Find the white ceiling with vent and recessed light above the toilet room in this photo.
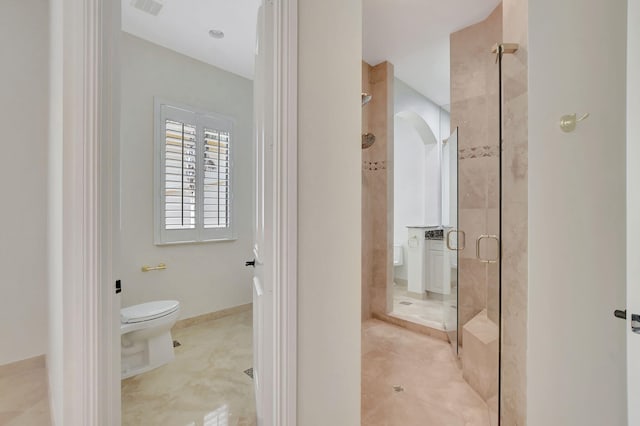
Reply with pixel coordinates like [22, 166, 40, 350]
[122, 0, 260, 79]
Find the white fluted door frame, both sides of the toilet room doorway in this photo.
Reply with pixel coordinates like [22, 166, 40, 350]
[58, 0, 298, 426]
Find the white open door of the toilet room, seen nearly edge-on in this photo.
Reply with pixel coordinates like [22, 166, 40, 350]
[253, 0, 274, 426]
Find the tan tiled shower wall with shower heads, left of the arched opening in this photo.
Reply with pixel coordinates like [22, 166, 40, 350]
[358, 62, 393, 320]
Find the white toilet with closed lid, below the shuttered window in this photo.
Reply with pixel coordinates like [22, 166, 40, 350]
[120, 300, 180, 379]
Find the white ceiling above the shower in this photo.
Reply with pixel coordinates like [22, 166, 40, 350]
[363, 0, 500, 107]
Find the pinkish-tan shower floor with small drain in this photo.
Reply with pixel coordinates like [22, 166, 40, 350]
[361, 320, 491, 426]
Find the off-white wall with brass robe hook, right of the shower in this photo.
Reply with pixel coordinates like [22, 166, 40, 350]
[527, 0, 637, 426]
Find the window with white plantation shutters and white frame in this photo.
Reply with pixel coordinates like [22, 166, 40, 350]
[155, 100, 233, 244]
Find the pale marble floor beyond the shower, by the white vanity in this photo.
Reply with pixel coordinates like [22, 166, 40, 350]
[391, 284, 457, 331]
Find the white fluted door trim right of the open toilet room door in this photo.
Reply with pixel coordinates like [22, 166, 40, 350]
[273, 0, 298, 426]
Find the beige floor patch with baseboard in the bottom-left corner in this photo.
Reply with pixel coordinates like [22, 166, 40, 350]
[0, 357, 51, 426]
